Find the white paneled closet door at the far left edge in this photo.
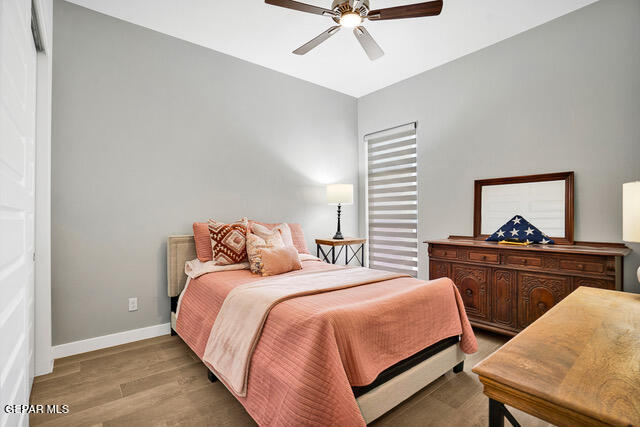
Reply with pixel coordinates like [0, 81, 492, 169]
[0, 0, 36, 426]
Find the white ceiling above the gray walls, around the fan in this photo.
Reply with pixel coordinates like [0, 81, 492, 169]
[63, 0, 596, 97]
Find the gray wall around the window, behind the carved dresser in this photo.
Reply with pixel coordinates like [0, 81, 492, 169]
[358, 0, 640, 292]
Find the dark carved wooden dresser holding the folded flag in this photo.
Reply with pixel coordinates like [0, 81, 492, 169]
[425, 238, 631, 335]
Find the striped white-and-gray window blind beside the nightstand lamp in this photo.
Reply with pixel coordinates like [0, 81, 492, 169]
[365, 123, 418, 277]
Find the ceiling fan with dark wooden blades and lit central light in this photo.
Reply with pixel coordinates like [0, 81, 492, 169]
[265, 0, 442, 61]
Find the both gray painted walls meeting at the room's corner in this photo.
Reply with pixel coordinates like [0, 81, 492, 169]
[52, 0, 640, 345]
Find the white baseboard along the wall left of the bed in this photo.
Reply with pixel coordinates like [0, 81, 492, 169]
[51, 323, 171, 359]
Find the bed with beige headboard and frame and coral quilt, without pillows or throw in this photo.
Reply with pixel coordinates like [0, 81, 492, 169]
[167, 235, 477, 425]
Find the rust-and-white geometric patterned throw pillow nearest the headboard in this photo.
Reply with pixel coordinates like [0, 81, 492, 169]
[208, 218, 248, 265]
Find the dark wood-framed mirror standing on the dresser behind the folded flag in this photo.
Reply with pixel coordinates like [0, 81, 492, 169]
[473, 172, 573, 245]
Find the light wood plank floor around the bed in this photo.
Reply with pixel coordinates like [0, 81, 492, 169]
[30, 331, 548, 427]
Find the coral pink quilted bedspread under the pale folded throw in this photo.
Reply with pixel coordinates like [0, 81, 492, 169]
[176, 261, 477, 426]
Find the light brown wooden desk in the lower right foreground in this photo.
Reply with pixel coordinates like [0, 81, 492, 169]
[473, 287, 640, 426]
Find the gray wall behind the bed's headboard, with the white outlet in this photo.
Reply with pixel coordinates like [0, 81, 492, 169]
[52, 0, 357, 345]
